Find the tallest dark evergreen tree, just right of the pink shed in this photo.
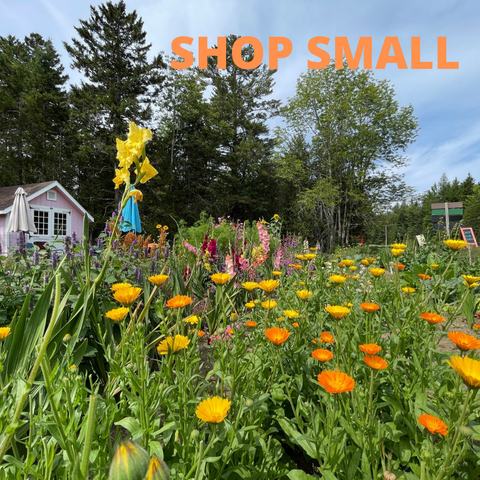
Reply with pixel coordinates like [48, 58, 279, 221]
[64, 0, 165, 229]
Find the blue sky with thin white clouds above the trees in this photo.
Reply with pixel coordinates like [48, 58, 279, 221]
[0, 0, 480, 192]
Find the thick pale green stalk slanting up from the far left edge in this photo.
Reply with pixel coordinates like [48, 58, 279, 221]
[0, 273, 60, 462]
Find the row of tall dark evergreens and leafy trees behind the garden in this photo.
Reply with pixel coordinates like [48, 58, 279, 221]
[0, 1, 476, 250]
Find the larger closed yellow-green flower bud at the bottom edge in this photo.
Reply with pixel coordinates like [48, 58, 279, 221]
[108, 440, 149, 480]
